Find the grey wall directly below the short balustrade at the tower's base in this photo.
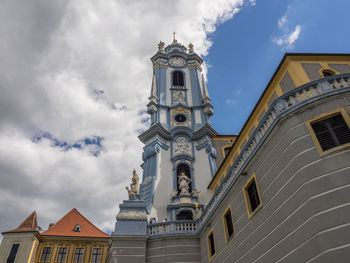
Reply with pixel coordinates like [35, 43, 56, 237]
[146, 235, 201, 263]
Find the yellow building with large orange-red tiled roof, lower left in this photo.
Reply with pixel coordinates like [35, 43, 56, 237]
[35, 208, 110, 263]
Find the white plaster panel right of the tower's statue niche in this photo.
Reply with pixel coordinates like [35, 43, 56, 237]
[193, 148, 212, 204]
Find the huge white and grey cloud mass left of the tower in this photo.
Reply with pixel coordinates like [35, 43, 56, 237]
[0, 0, 247, 235]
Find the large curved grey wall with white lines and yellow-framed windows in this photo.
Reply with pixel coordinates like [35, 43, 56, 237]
[200, 94, 350, 263]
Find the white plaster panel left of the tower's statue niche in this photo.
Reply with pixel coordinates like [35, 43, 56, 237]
[149, 148, 173, 222]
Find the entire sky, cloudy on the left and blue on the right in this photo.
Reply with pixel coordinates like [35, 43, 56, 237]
[0, 0, 350, 235]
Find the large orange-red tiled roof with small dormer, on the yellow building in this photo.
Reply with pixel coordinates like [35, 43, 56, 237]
[41, 208, 110, 237]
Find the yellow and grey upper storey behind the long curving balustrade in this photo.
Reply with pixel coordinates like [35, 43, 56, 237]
[208, 53, 350, 194]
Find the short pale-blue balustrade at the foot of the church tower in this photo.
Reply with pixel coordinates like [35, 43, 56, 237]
[148, 220, 197, 235]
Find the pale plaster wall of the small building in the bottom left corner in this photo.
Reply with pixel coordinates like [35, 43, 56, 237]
[0, 232, 39, 263]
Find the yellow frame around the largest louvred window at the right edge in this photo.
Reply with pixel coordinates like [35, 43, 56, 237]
[305, 108, 350, 156]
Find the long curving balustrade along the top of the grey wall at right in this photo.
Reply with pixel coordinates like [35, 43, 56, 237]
[198, 73, 350, 231]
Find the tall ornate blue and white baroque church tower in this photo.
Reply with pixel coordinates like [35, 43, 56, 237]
[139, 34, 217, 221]
